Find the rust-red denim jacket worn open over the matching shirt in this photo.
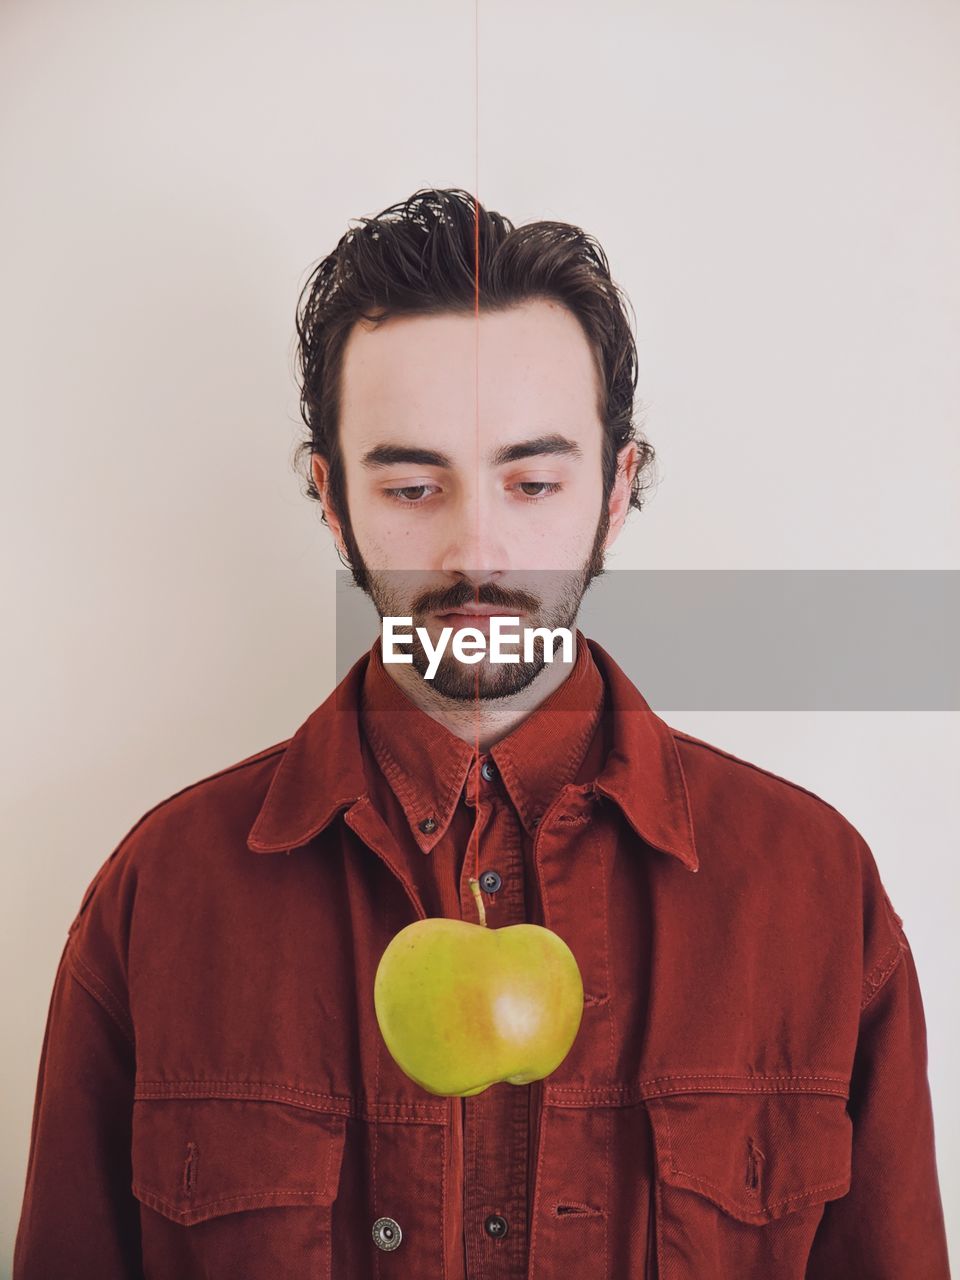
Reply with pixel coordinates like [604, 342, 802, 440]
[14, 634, 948, 1280]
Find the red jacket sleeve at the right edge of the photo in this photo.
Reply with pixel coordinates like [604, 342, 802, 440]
[806, 916, 950, 1280]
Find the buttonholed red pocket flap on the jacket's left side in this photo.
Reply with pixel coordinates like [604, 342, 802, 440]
[132, 1098, 347, 1226]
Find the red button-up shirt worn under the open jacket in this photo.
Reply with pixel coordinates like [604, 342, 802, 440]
[361, 627, 611, 1277]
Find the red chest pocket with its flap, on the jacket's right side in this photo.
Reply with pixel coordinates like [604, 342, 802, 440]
[646, 1093, 852, 1280]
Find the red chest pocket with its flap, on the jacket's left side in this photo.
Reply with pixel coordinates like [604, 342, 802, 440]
[132, 1098, 346, 1280]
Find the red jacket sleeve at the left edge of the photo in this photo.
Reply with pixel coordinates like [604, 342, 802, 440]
[13, 936, 143, 1280]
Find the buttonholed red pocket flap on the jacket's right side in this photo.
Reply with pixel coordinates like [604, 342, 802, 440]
[648, 1093, 852, 1224]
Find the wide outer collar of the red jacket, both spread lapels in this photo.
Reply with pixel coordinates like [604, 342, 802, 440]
[247, 635, 699, 872]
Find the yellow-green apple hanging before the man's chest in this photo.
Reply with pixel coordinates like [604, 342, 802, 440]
[374, 916, 584, 1098]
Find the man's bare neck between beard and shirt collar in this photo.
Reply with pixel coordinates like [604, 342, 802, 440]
[384, 628, 577, 753]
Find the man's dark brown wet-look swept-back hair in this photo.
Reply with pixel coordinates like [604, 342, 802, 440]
[296, 188, 654, 527]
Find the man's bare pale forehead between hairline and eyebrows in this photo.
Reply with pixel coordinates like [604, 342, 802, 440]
[340, 298, 600, 445]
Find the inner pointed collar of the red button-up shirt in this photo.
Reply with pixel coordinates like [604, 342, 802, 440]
[360, 632, 604, 854]
